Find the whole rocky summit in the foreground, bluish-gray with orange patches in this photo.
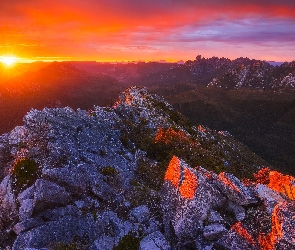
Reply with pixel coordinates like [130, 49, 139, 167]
[0, 87, 295, 250]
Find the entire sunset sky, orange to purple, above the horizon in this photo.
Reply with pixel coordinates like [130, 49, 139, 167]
[0, 0, 295, 61]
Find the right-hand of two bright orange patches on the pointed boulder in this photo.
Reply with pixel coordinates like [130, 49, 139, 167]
[179, 168, 198, 199]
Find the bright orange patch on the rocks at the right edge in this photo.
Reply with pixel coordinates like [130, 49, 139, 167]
[268, 171, 295, 200]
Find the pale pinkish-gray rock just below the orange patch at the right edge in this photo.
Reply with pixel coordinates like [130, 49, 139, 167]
[256, 184, 286, 214]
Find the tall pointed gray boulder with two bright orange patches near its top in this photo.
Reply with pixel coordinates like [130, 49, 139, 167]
[162, 156, 225, 239]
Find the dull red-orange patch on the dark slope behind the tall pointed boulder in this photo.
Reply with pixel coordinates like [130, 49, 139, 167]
[155, 127, 189, 144]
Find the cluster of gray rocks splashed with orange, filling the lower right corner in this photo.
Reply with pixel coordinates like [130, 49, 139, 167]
[162, 156, 295, 249]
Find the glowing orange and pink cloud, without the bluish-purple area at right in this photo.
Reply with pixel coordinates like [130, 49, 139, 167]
[0, 0, 295, 60]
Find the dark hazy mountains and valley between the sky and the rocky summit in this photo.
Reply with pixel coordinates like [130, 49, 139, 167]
[0, 56, 295, 174]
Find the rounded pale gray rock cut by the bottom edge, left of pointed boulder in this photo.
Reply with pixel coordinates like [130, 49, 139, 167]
[139, 231, 171, 250]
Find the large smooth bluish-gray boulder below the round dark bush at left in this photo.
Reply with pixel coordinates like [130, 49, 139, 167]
[34, 179, 70, 213]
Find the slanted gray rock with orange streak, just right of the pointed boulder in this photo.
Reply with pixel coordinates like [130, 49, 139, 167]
[215, 172, 257, 205]
